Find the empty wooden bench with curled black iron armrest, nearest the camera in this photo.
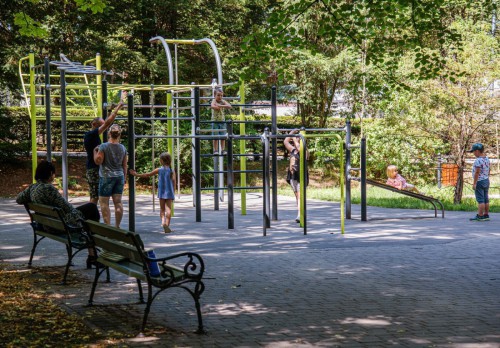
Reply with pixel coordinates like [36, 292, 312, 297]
[84, 220, 205, 335]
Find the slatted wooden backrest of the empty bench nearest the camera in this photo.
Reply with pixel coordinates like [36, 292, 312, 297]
[85, 220, 145, 264]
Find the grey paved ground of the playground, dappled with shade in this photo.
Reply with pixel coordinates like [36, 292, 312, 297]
[0, 194, 500, 348]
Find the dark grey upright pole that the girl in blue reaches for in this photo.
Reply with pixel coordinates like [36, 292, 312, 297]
[128, 94, 135, 232]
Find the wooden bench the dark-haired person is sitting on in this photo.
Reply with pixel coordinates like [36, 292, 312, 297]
[24, 203, 105, 284]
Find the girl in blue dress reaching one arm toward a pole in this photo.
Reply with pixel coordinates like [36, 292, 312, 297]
[129, 152, 176, 233]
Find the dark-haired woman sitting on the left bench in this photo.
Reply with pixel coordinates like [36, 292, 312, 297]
[16, 160, 101, 268]
